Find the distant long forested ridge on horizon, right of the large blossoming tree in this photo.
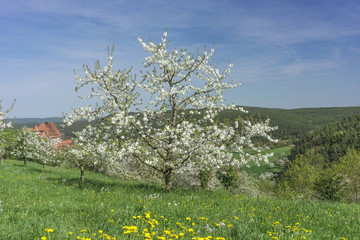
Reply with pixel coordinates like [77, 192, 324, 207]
[220, 106, 360, 139]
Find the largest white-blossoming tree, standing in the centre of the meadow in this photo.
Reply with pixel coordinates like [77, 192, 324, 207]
[64, 31, 274, 190]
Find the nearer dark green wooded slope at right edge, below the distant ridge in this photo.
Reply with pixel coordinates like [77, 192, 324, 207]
[291, 114, 360, 163]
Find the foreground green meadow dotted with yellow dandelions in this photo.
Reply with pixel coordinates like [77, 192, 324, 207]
[0, 160, 360, 240]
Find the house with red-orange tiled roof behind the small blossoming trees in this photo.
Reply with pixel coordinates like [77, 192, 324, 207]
[29, 122, 72, 149]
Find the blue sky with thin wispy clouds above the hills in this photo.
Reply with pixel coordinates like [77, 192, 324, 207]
[0, 0, 360, 118]
